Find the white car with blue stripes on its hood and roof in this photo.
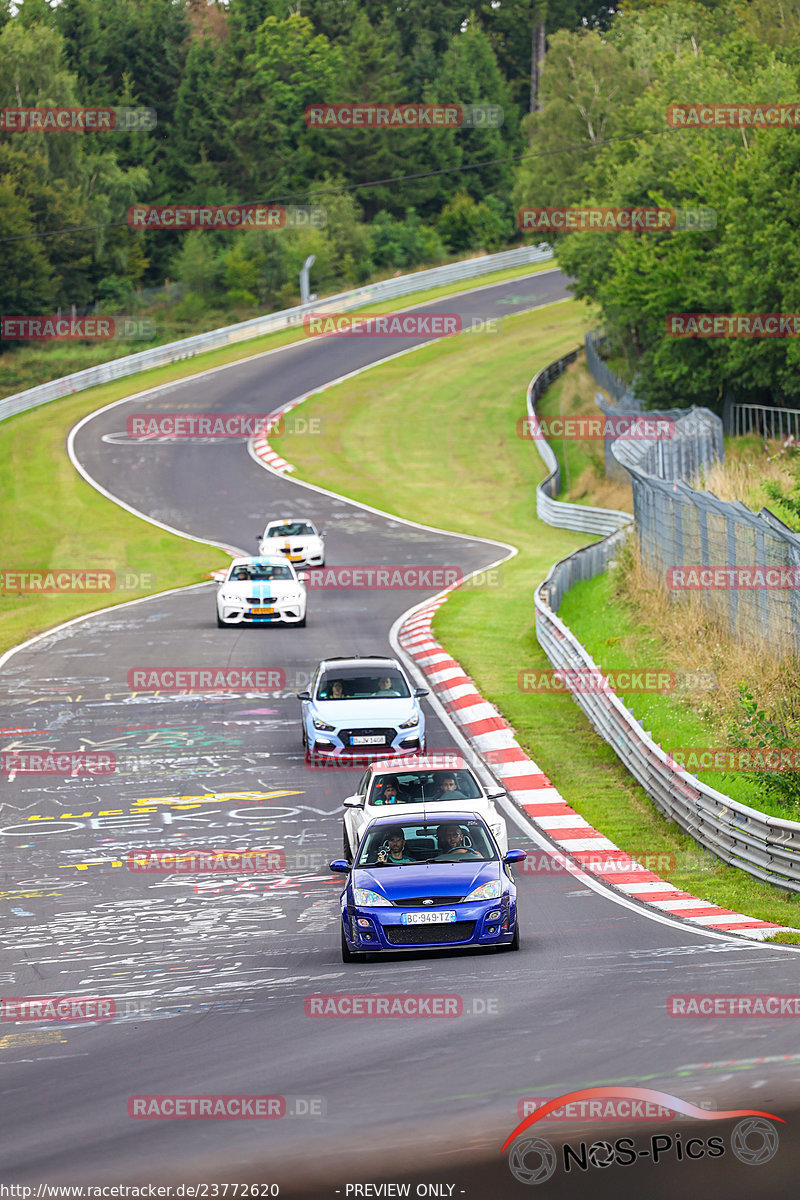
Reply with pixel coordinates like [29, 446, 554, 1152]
[217, 557, 306, 628]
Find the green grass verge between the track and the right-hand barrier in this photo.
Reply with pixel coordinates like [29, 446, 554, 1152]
[273, 301, 800, 925]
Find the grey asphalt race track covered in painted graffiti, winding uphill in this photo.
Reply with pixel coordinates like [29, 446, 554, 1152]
[0, 275, 796, 1196]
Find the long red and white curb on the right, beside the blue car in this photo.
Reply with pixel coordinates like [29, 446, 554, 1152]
[398, 595, 786, 940]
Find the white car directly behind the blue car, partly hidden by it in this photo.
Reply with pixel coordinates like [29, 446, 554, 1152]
[344, 751, 509, 862]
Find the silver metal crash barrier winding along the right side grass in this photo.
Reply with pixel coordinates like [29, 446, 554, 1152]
[528, 338, 800, 892]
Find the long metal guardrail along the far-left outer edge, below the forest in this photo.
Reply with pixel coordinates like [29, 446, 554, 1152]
[0, 245, 553, 420]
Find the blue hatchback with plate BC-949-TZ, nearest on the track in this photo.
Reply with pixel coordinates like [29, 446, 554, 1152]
[330, 811, 525, 962]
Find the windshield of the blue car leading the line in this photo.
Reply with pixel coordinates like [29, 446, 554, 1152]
[356, 821, 498, 866]
